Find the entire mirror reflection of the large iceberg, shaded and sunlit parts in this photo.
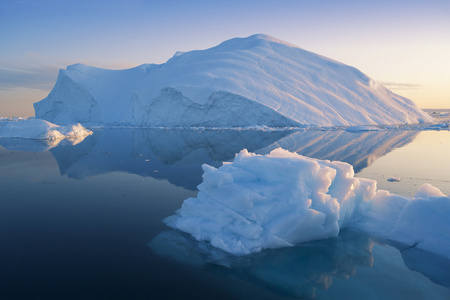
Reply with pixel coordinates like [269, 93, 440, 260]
[0, 128, 418, 190]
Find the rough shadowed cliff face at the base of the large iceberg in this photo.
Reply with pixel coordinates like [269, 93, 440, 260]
[134, 87, 300, 127]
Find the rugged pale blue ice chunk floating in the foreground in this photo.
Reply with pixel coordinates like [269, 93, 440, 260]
[165, 148, 450, 257]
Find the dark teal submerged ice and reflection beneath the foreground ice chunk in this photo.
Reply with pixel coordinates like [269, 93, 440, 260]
[149, 229, 450, 299]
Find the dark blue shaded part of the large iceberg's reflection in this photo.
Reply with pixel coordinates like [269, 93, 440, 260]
[51, 129, 289, 190]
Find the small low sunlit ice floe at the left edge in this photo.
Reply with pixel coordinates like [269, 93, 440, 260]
[0, 119, 92, 140]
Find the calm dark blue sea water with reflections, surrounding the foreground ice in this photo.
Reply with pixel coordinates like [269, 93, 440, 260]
[0, 129, 450, 299]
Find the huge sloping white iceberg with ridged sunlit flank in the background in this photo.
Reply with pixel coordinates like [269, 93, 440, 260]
[34, 34, 432, 127]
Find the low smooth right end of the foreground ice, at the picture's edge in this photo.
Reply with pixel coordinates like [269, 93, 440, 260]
[356, 183, 450, 258]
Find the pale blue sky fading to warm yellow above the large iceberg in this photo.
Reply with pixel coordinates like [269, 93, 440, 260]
[0, 0, 450, 116]
